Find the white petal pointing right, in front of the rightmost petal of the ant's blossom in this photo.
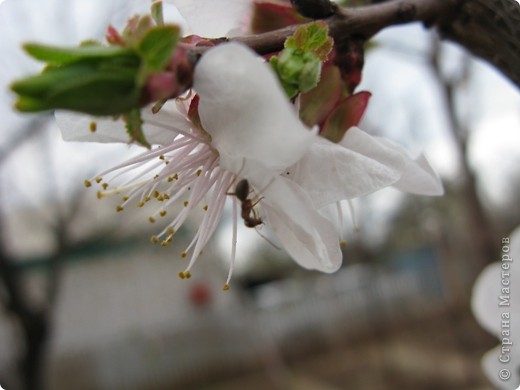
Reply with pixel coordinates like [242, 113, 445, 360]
[289, 134, 406, 208]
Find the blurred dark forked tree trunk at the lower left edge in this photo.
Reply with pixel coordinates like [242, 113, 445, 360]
[0, 116, 86, 390]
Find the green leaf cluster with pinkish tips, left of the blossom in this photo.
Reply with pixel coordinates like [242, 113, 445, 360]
[11, 7, 180, 119]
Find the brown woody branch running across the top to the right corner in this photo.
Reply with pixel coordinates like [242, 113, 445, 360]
[223, 0, 520, 87]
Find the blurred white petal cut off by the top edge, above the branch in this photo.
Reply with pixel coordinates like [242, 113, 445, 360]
[170, 0, 252, 38]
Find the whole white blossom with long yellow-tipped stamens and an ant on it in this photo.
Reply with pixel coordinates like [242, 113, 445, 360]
[58, 43, 442, 285]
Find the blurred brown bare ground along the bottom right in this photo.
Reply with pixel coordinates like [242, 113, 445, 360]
[192, 309, 496, 390]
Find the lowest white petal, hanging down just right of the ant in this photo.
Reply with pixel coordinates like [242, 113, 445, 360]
[262, 177, 342, 272]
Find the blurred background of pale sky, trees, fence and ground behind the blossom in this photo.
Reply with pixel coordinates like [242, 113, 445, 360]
[0, 0, 520, 390]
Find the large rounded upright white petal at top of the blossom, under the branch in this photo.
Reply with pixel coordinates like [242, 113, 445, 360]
[194, 43, 317, 178]
